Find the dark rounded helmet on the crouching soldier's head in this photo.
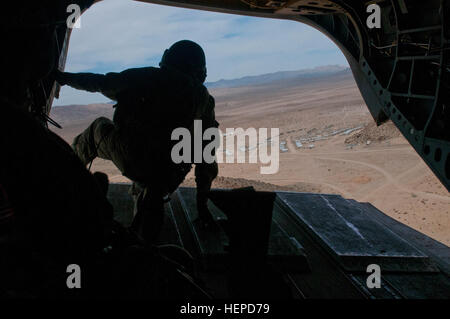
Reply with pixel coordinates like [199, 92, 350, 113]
[159, 40, 206, 83]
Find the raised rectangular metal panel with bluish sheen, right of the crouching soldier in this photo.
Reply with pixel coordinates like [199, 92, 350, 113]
[278, 192, 438, 272]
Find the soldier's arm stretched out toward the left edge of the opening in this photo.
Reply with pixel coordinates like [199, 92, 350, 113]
[54, 71, 127, 100]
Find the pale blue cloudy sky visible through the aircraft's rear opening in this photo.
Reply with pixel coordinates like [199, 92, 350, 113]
[54, 0, 347, 105]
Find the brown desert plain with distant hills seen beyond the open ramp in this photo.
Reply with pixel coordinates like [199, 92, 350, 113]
[50, 67, 450, 246]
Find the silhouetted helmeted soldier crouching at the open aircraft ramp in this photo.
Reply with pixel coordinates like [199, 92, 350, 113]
[56, 40, 218, 241]
